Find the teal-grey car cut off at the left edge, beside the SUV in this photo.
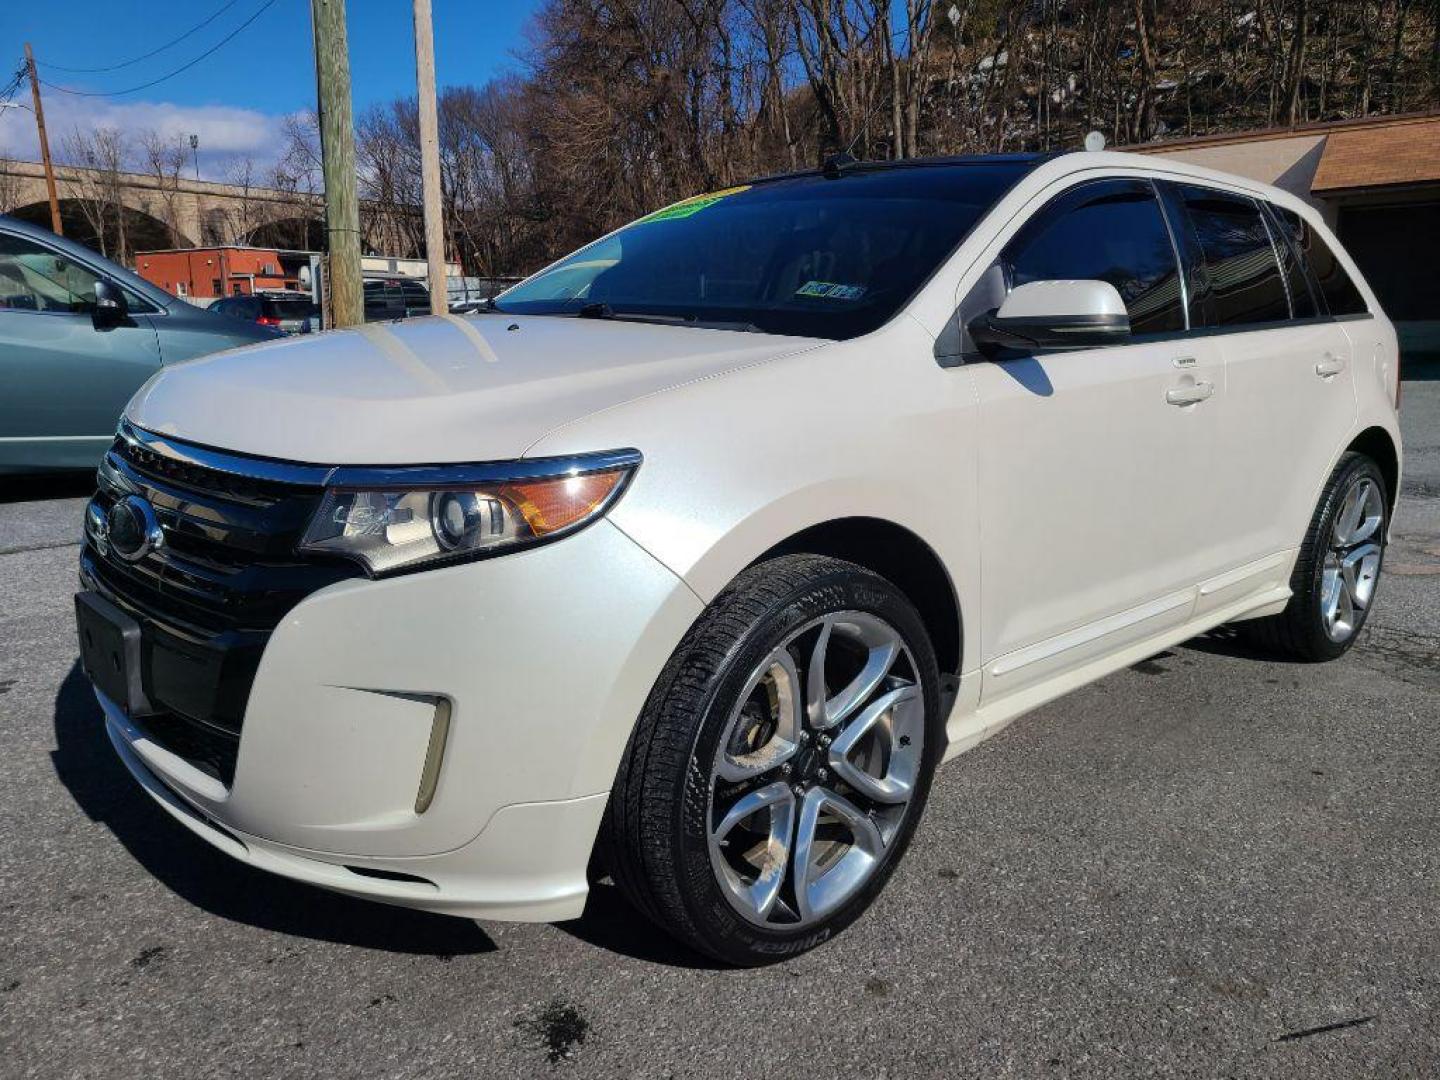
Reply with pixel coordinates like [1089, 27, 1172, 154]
[0, 215, 279, 474]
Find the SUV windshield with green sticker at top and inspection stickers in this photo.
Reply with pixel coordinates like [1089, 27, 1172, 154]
[495, 161, 1028, 338]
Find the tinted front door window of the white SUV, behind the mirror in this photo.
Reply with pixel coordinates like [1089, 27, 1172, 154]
[1001, 180, 1185, 334]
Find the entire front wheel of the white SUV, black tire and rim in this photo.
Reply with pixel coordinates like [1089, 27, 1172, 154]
[605, 554, 945, 966]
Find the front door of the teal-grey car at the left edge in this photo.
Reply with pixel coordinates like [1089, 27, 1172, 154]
[0, 232, 160, 468]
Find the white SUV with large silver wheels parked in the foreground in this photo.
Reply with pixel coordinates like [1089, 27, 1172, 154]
[76, 154, 1400, 963]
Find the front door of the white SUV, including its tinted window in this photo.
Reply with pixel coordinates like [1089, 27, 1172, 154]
[962, 179, 1225, 703]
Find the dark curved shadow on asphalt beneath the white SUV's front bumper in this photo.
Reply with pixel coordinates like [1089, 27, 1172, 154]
[52, 662, 495, 956]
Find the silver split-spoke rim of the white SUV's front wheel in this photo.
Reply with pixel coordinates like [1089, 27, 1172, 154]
[708, 611, 926, 929]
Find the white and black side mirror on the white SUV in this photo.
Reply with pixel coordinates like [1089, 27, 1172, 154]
[966, 281, 1130, 353]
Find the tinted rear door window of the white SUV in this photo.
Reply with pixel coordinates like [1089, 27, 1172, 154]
[1181, 186, 1290, 327]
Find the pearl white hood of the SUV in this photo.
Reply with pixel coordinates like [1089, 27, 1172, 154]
[125, 314, 824, 465]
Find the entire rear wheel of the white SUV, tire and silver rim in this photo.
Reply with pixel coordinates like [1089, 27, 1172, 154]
[1240, 452, 1390, 661]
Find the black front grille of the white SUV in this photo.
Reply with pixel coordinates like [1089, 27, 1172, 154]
[81, 428, 360, 785]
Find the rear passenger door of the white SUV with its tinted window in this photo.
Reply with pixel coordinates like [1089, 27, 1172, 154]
[1174, 184, 1356, 584]
